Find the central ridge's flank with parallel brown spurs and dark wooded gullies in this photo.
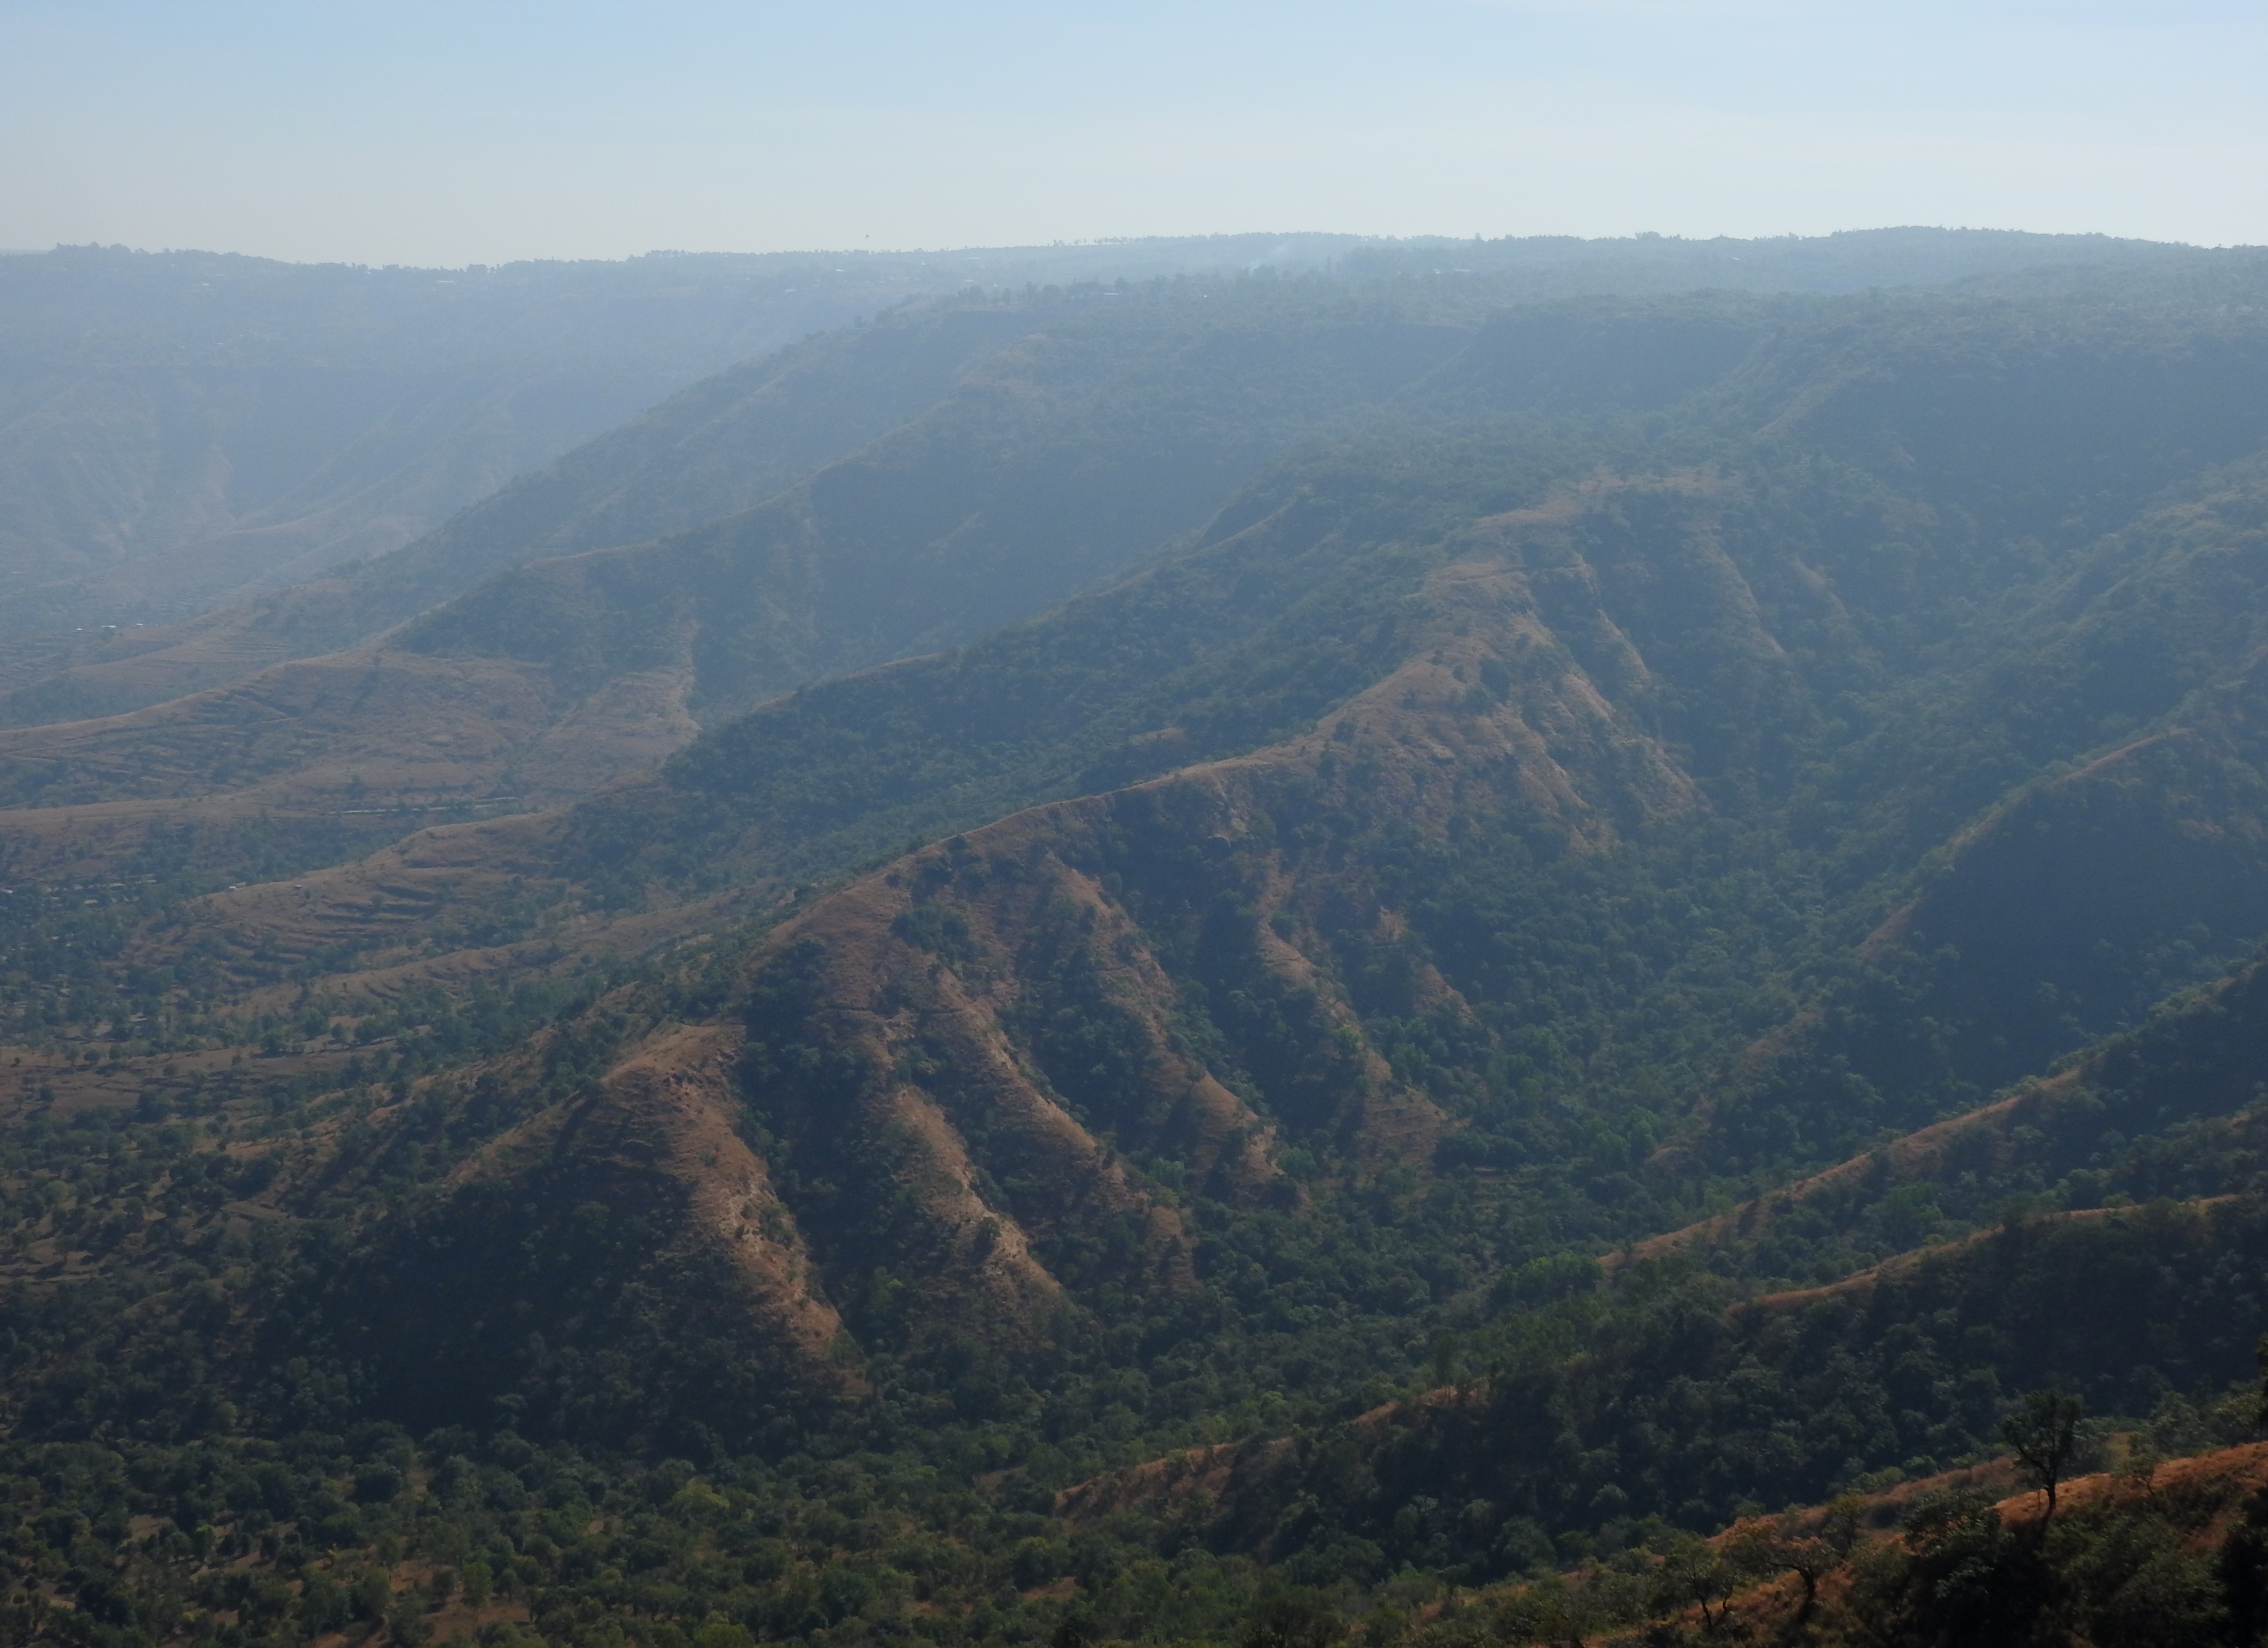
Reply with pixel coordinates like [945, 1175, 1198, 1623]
[284, 474, 1742, 1417]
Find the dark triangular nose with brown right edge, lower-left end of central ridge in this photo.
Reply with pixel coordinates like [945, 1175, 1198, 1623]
[327, 1029, 864, 1446]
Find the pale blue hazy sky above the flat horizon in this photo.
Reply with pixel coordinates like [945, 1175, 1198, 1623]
[0, 0, 2268, 263]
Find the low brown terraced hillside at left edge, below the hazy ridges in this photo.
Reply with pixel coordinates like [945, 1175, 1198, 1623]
[0, 646, 694, 875]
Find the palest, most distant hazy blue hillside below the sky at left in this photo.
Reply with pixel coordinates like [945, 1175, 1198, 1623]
[0, 236, 1560, 639]
